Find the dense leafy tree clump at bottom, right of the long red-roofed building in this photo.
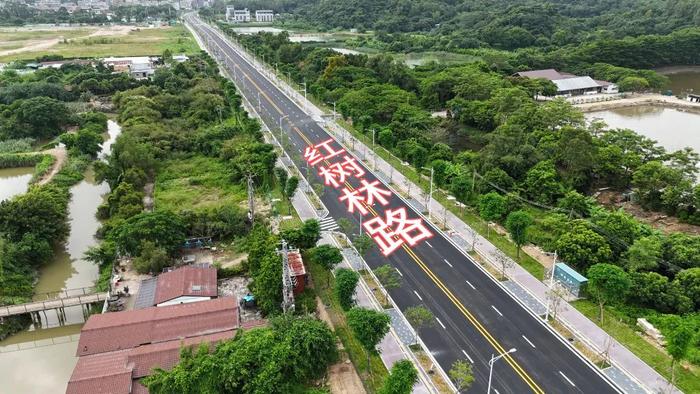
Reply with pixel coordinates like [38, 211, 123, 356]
[143, 315, 337, 393]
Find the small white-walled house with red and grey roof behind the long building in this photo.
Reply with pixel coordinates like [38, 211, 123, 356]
[134, 264, 218, 309]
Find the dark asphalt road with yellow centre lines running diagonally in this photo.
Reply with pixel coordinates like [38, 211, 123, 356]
[189, 16, 618, 393]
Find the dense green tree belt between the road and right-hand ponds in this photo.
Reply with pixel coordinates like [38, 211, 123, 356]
[222, 25, 700, 378]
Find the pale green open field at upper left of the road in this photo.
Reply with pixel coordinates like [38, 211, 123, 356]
[0, 25, 199, 62]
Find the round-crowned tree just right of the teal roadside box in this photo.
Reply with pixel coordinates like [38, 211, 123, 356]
[588, 263, 632, 324]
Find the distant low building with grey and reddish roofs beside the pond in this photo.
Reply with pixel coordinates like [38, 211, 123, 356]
[514, 68, 619, 96]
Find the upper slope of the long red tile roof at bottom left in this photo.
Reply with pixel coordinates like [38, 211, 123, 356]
[76, 297, 239, 356]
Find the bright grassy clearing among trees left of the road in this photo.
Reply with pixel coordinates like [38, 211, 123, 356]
[155, 156, 246, 211]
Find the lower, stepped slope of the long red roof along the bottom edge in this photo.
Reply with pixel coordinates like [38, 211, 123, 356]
[66, 330, 235, 394]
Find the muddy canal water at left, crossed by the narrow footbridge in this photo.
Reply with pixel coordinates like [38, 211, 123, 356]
[0, 120, 121, 393]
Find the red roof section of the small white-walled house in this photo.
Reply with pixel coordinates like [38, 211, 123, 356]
[155, 265, 217, 304]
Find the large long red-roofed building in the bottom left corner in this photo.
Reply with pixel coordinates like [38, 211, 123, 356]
[66, 297, 262, 394]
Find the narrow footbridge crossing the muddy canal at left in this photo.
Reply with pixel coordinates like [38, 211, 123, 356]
[0, 287, 108, 318]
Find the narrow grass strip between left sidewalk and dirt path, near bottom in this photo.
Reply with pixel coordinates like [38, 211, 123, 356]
[308, 263, 389, 393]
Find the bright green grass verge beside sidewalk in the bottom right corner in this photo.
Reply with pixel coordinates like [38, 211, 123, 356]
[572, 300, 700, 393]
